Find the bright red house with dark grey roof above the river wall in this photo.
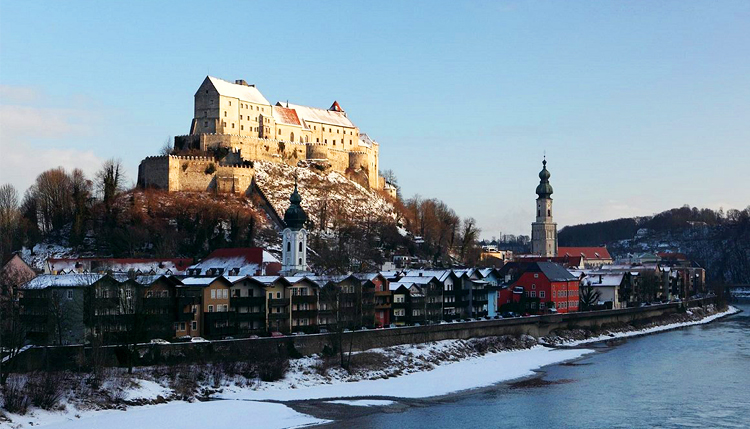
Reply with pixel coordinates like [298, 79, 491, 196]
[513, 262, 579, 313]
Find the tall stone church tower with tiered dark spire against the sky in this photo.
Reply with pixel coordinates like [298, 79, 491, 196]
[531, 158, 557, 256]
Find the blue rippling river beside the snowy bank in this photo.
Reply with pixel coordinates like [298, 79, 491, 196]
[327, 302, 750, 428]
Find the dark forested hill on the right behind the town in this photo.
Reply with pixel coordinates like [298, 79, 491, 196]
[559, 206, 750, 283]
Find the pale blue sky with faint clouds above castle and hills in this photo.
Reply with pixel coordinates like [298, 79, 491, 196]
[0, 0, 750, 238]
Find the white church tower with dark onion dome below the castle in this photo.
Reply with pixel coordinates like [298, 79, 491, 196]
[281, 183, 307, 276]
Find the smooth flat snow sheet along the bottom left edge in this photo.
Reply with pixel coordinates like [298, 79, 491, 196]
[0, 401, 328, 429]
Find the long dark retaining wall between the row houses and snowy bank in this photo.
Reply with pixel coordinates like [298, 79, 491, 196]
[13, 298, 714, 371]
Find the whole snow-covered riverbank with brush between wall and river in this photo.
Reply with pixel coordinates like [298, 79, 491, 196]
[0, 307, 739, 429]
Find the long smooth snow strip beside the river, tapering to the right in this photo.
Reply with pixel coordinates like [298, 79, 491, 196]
[217, 346, 593, 401]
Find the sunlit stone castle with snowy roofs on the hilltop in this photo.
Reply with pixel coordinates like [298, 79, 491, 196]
[138, 76, 395, 196]
